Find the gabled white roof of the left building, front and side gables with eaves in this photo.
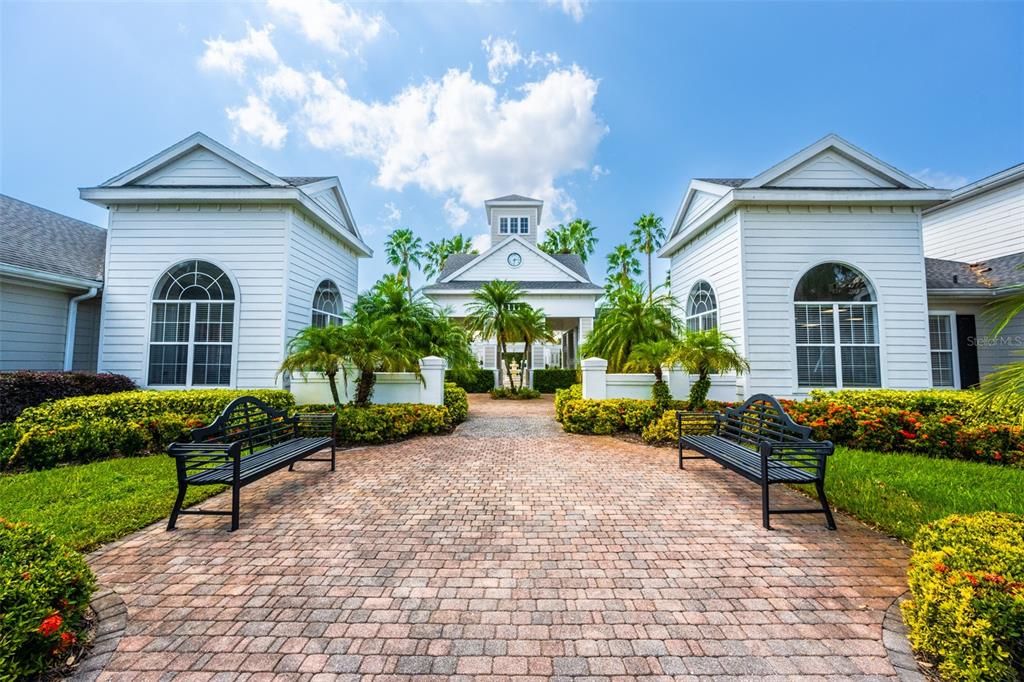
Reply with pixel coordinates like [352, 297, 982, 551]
[79, 132, 373, 256]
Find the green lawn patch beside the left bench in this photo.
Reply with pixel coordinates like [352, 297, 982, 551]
[0, 455, 222, 551]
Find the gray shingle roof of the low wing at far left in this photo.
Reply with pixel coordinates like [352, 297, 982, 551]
[0, 195, 106, 281]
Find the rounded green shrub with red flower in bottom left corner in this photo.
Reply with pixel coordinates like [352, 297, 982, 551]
[0, 518, 96, 680]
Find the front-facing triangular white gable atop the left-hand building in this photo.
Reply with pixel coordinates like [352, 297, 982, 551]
[100, 132, 288, 187]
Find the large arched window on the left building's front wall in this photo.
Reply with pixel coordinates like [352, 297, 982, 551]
[148, 260, 234, 386]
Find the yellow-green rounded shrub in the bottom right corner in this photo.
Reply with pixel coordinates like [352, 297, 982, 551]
[902, 512, 1024, 682]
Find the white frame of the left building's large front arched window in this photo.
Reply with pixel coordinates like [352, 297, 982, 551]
[142, 258, 242, 390]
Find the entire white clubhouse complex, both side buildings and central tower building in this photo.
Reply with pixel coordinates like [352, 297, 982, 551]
[0, 133, 1024, 399]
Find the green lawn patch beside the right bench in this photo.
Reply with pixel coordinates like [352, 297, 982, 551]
[806, 447, 1024, 541]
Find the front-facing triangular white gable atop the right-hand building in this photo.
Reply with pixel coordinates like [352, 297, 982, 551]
[740, 134, 928, 189]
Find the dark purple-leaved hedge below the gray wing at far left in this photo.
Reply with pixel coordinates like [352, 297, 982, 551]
[0, 372, 138, 422]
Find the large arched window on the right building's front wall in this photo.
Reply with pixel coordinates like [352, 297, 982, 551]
[794, 263, 882, 388]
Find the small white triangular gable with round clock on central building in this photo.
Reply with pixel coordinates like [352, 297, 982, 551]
[438, 237, 589, 283]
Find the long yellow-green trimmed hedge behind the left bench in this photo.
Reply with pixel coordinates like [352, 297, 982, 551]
[7, 389, 295, 469]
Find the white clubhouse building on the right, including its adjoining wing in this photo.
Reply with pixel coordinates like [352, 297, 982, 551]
[659, 135, 1024, 398]
